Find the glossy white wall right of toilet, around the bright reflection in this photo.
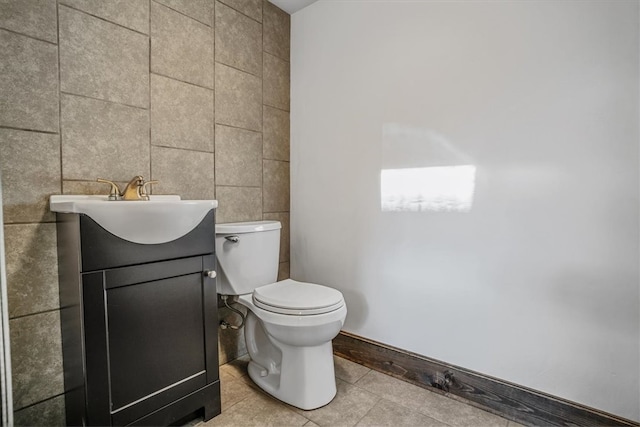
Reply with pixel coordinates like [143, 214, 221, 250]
[291, 0, 640, 421]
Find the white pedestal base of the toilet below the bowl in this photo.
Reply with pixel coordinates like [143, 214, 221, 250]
[248, 341, 336, 410]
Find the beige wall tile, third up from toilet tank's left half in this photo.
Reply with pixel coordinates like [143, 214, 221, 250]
[215, 64, 262, 131]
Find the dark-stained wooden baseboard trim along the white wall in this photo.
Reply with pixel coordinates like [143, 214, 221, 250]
[333, 332, 640, 427]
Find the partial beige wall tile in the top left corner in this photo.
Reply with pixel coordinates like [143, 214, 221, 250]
[0, 0, 58, 43]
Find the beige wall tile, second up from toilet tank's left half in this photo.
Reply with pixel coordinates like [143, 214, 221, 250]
[216, 125, 262, 187]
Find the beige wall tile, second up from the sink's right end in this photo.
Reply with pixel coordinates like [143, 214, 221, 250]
[151, 74, 213, 151]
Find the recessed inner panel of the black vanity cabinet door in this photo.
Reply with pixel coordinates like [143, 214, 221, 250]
[107, 273, 206, 412]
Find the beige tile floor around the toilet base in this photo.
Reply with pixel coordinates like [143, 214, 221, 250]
[189, 357, 519, 427]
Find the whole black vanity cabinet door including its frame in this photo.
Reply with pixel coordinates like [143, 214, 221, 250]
[83, 255, 217, 425]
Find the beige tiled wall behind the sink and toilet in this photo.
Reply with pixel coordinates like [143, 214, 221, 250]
[0, 0, 290, 425]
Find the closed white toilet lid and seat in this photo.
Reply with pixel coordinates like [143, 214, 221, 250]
[253, 279, 344, 315]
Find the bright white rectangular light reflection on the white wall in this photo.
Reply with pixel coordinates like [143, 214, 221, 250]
[380, 165, 476, 212]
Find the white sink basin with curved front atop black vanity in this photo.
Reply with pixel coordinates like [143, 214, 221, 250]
[49, 195, 218, 244]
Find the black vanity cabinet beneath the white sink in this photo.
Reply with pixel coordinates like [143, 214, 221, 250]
[57, 209, 220, 426]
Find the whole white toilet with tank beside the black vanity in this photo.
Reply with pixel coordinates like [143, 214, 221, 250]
[216, 221, 347, 410]
